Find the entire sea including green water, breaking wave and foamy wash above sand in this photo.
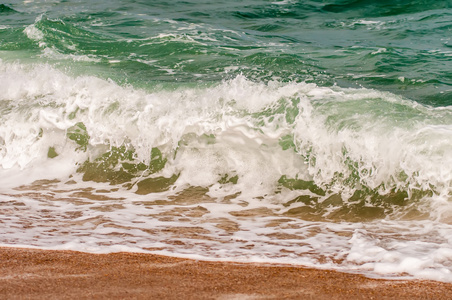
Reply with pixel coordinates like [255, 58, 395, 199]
[0, 0, 452, 281]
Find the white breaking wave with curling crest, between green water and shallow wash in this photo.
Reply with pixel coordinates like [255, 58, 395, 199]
[0, 63, 452, 216]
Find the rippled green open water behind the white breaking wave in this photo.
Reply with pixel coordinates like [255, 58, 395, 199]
[0, 0, 452, 107]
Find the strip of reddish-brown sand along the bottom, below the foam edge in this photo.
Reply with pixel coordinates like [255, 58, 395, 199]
[0, 248, 452, 300]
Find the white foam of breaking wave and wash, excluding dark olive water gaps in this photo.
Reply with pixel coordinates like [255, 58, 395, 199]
[0, 61, 452, 282]
